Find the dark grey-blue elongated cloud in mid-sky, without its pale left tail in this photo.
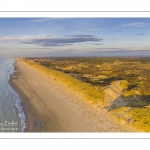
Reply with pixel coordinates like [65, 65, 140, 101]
[22, 35, 103, 47]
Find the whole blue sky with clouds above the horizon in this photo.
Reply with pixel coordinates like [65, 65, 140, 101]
[0, 18, 150, 57]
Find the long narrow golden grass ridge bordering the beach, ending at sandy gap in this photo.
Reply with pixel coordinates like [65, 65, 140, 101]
[23, 59, 104, 106]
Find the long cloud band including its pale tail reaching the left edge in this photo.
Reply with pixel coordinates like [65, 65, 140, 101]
[0, 34, 103, 47]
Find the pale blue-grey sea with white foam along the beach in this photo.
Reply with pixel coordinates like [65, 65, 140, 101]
[0, 57, 27, 132]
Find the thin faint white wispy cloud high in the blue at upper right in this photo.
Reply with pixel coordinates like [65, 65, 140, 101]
[116, 22, 147, 28]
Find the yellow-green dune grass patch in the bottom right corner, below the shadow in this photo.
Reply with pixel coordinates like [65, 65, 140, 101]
[110, 107, 150, 132]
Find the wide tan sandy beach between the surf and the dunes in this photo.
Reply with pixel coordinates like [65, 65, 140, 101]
[10, 60, 126, 132]
